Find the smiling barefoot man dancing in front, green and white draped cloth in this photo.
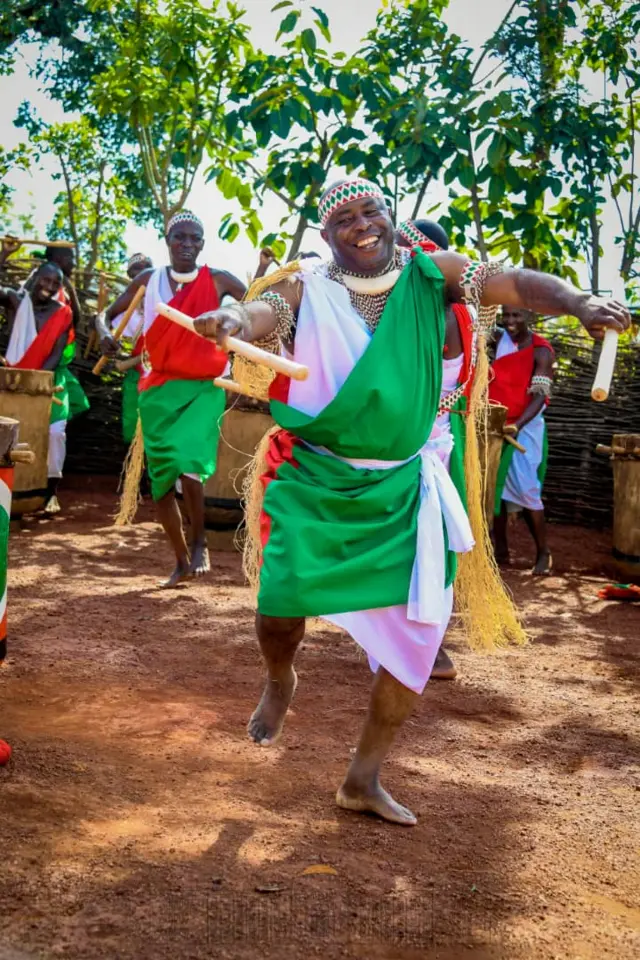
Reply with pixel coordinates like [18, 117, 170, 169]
[196, 179, 629, 825]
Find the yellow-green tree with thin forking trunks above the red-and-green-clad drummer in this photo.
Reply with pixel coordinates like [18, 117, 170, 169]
[91, 0, 250, 225]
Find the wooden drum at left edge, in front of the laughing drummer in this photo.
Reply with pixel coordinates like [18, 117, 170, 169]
[0, 367, 53, 516]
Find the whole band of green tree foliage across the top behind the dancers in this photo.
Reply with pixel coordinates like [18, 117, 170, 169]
[0, 0, 640, 289]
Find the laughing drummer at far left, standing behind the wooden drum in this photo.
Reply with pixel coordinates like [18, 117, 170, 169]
[0, 262, 89, 514]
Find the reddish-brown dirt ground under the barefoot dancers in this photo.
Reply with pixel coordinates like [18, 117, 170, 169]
[0, 484, 640, 960]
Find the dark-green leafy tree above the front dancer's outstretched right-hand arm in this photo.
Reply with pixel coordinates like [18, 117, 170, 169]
[367, 0, 576, 270]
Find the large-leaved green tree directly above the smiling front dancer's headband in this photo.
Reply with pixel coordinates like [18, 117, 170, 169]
[208, 0, 390, 258]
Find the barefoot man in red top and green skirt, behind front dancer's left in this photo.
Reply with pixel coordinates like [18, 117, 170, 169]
[97, 210, 245, 587]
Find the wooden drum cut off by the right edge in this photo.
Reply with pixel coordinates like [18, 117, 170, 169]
[611, 433, 640, 582]
